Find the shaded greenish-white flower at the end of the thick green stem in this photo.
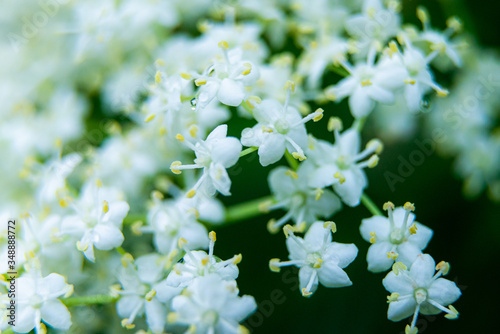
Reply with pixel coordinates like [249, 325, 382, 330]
[268, 164, 342, 233]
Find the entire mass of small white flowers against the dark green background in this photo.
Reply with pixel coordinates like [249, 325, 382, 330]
[0, 0, 484, 334]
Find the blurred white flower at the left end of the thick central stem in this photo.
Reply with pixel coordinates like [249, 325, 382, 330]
[143, 194, 208, 254]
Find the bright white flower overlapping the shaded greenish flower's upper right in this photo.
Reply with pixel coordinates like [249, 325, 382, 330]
[306, 122, 383, 206]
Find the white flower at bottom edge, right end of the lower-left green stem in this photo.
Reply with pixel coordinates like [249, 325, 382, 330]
[114, 254, 182, 334]
